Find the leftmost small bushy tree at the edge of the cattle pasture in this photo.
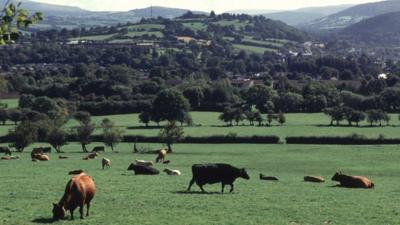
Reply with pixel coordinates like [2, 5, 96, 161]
[9, 120, 37, 152]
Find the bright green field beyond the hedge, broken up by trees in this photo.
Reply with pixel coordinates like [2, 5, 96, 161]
[0, 112, 400, 141]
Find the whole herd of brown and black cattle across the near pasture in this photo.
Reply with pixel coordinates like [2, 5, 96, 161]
[0, 146, 374, 220]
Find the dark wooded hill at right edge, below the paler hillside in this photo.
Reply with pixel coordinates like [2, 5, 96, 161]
[340, 12, 400, 45]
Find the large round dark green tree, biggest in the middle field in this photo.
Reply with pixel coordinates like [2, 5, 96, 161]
[152, 89, 189, 121]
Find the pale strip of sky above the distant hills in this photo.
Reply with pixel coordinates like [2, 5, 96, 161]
[33, 0, 377, 13]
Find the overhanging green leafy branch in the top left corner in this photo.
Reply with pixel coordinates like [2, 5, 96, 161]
[0, 1, 43, 45]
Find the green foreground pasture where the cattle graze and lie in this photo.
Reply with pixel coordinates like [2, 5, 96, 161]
[0, 144, 400, 225]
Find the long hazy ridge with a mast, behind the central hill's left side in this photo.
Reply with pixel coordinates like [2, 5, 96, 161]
[14, 0, 206, 29]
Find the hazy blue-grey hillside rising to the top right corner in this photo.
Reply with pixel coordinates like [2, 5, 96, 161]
[303, 0, 400, 30]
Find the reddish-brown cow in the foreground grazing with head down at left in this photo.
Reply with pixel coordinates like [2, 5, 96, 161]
[53, 173, 96, 220]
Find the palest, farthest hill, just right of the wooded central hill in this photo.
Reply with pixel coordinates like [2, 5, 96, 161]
[263, 5, 352, 26]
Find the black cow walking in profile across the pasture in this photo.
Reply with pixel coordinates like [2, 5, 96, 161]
[187, 163, 250, 193]
